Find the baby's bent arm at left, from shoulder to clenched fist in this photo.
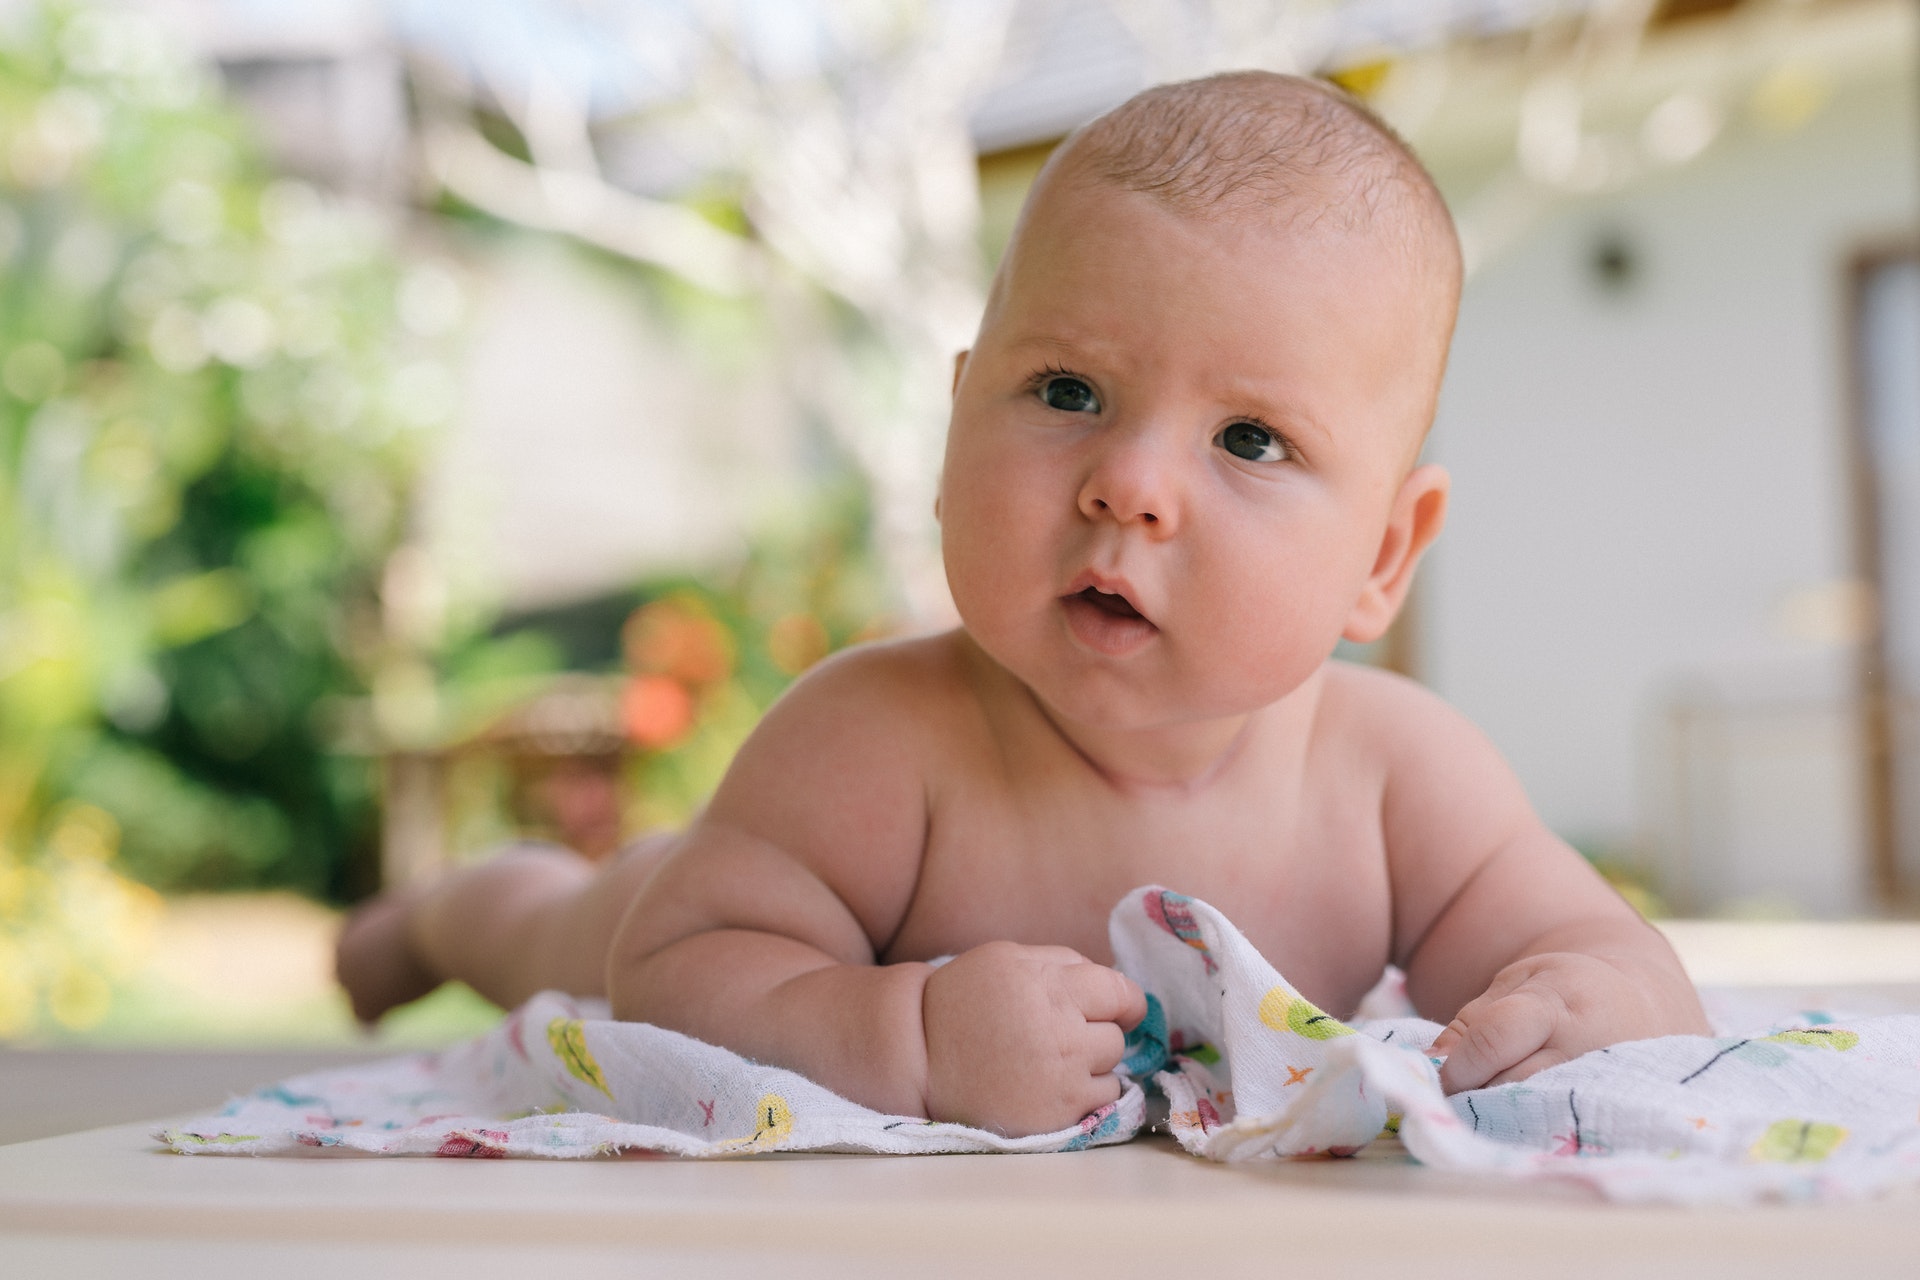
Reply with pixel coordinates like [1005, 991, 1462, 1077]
[607, 649, 1144, 1132]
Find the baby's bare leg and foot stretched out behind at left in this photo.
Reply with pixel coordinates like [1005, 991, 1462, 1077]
[334, 835, 678, 1023]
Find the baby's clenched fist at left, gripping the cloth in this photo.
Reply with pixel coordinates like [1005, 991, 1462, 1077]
[922, 942, 1146, 1136]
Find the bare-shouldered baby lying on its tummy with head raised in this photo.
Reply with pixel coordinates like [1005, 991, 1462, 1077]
[340, 73, 1707, 1134]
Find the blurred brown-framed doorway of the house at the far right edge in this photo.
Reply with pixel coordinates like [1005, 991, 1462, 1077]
[1851, 246, 1920, 908]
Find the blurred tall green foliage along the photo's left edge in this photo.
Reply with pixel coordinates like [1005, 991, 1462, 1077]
[0, 4, 439, 1021]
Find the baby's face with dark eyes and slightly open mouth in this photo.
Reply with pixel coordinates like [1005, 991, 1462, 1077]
[941, 177, 1442, 729]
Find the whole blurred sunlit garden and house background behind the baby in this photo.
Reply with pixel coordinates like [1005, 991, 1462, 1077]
[0, 0, 1920, 1044]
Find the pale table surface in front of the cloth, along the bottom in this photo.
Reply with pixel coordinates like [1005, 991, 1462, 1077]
[0, 1125, 1920, 1280]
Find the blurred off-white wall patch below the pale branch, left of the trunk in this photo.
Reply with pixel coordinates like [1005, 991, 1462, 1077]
[422, 240, 818, 608]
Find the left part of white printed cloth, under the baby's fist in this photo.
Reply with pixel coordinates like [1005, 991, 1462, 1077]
[157, 992, 1146, 1157]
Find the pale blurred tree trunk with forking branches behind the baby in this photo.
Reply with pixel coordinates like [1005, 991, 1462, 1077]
[399, 0, 1012, 622]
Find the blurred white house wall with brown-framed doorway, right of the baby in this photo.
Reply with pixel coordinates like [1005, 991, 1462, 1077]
[1421, 0, 1920, 913]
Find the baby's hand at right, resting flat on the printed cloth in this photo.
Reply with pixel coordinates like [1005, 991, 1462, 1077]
[1432, 952, 1707, 1094]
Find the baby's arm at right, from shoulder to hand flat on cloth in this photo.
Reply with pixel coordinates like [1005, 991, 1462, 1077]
[1382, 687, 1707, 1090]
